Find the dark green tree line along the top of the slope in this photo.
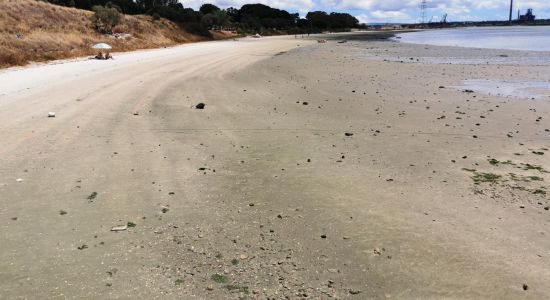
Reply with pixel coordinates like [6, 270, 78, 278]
[42, 0, 361, 36]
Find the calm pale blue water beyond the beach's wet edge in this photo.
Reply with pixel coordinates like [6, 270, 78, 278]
[397, 26, 550, 51]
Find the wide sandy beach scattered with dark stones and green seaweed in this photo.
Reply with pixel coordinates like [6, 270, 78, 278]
[0, 35, 550, 299]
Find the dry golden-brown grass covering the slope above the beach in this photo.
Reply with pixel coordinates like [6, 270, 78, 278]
[0, 0, 235, 68]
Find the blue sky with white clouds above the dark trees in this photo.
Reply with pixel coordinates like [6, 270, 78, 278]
[180, 0, 550, 23]
